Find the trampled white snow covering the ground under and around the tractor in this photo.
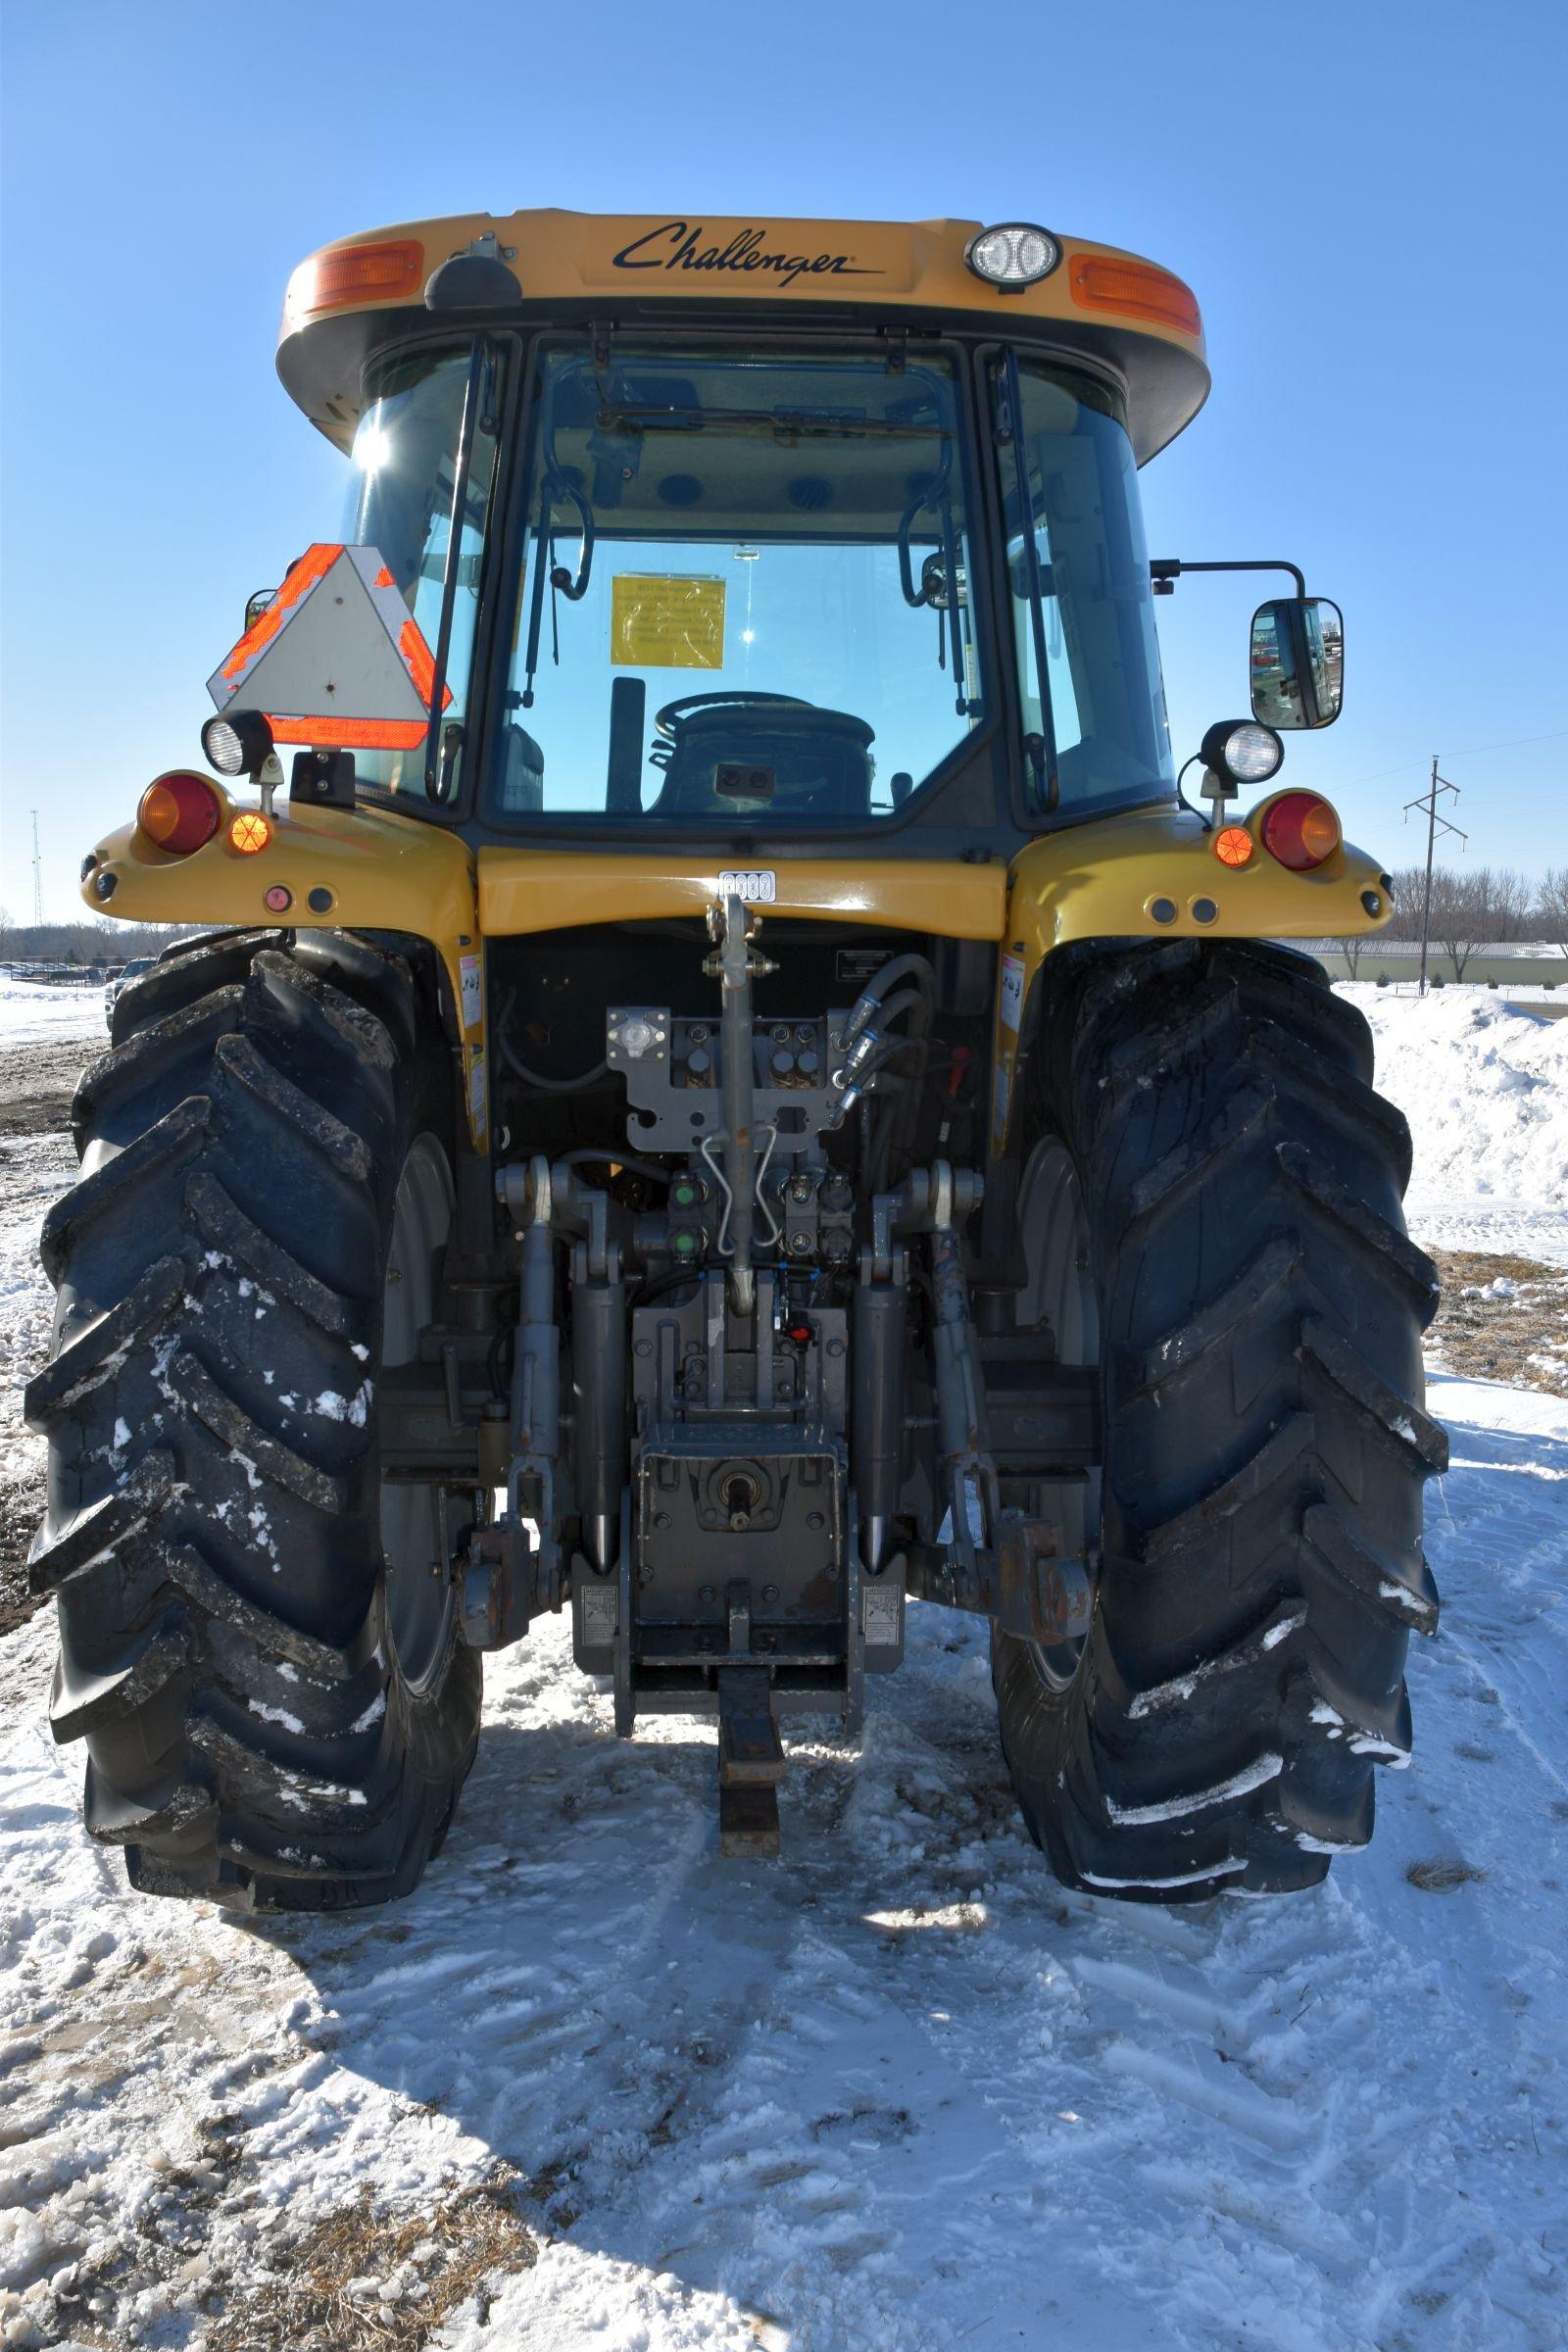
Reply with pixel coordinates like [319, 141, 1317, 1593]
[0, 964, 1568, 2352]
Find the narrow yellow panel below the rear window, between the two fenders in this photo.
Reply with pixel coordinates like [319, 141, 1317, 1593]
[479, 849, 1006, 939]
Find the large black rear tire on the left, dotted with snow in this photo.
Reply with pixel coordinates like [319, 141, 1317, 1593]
[28, 931, 479, 1910]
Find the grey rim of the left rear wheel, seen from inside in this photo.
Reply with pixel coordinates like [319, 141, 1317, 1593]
[381, 1136, 454, 1689]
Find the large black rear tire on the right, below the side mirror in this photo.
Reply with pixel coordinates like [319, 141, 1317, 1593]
[992, 943, 1446, 1903]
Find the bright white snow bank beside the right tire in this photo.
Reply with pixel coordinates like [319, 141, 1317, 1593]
[1340, 981, 1568, 1263]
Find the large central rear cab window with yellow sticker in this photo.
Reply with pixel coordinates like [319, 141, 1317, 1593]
[489, 336, 983, 828]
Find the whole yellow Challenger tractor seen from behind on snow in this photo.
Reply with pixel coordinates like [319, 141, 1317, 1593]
[28, 212, 1444, 1907]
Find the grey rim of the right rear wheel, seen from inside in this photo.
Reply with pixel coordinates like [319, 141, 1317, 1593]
[1018, 1139, 1101, 1691]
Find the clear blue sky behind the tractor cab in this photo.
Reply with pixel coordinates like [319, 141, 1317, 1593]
[0, 0, 1568, 919]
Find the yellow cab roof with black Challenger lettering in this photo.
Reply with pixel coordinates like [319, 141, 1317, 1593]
[277, 212, 1208, 466]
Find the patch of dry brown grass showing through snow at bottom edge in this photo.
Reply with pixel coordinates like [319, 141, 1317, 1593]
[207, 2176, 538, 2352]
